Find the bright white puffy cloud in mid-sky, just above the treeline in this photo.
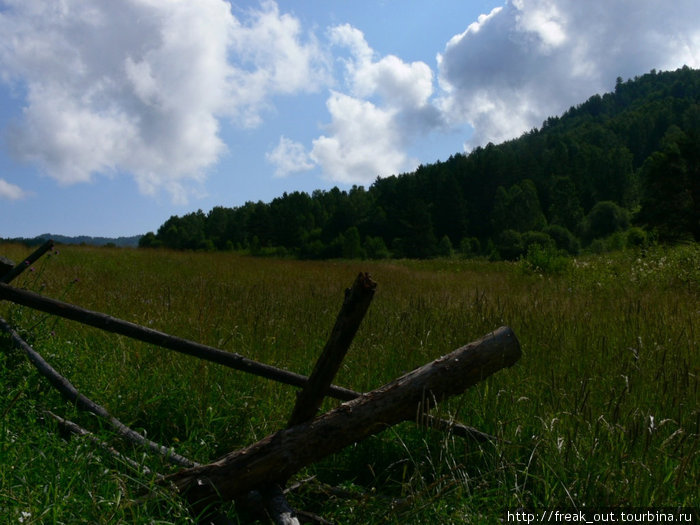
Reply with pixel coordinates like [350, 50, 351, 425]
[296, 24, 442, 184]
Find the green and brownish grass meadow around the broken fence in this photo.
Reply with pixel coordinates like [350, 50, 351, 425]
[0, 244, 700, 524]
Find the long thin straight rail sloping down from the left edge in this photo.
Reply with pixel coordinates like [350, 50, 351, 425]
[0, 283, 358, 400]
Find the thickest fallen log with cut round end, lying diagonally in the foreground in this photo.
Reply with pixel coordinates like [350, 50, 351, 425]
[166, 327, 520, 505]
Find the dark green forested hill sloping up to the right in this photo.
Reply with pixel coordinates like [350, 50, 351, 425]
[140, 67, 700, 258]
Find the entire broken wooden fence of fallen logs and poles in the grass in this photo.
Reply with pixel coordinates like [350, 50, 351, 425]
[0, 241, 520, 524]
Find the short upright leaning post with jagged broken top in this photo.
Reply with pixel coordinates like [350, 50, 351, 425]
[287, 273, 377, 427]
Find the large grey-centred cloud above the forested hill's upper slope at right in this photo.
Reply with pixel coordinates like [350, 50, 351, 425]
[438, 0, 700, 147]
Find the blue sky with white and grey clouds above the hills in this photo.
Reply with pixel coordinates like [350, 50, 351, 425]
[0, 0, 700, 237]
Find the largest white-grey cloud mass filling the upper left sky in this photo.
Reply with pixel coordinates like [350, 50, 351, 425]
[0, 0, 328, 201]
